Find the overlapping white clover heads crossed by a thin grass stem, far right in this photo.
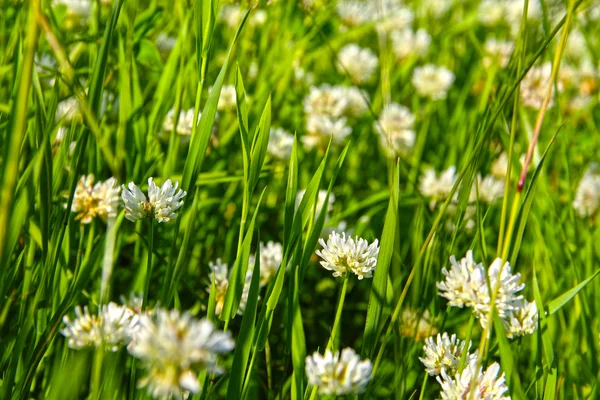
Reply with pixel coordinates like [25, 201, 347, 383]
[436, 250, 537, 337]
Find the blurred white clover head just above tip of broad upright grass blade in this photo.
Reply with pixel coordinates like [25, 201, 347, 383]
[373, 103, 416, 155]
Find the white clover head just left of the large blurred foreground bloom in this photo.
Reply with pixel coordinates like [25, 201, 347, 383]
[60, 302, 139, 352]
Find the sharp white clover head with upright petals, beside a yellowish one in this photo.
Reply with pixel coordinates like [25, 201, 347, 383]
[121, 178, 187, 222]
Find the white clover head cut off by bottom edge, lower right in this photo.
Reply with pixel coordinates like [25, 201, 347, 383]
[436, 363, 510, 400]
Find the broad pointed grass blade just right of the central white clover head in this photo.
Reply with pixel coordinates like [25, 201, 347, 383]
[361, 163, 400, 358]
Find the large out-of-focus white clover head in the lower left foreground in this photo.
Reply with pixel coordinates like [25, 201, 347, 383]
[128, 309, 234, 399]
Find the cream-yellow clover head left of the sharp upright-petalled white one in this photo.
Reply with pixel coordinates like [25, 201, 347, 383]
[71, 174, 121, 224]
